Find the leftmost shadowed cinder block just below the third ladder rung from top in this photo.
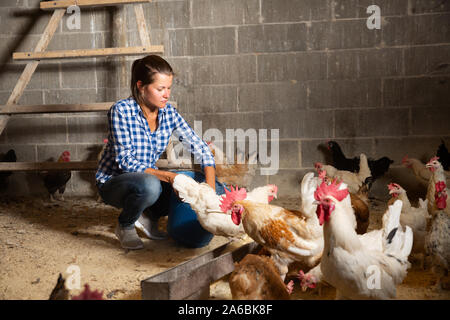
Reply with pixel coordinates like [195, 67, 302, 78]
[5, 116, 67, 144]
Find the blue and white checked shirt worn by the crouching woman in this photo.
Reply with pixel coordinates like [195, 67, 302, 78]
[95, 97, 215, 183]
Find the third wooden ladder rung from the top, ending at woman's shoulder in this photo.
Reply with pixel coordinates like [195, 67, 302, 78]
[0, 102, 114, 114]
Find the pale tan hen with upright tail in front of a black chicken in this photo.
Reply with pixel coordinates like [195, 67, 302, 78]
[314, 153, 371, 193]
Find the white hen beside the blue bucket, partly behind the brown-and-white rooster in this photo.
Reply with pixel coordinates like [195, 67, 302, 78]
[173, 174, 278, 238]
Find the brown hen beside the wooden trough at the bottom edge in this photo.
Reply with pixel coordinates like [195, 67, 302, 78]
[228, 254, 293, 300]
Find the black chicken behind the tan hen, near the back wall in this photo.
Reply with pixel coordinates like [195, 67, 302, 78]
[327, 141, 394, 181]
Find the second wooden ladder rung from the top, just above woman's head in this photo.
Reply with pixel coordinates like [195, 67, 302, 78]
[13, 45, 164, 60]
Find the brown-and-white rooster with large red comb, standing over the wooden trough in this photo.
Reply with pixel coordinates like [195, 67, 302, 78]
[220, 182, 323, 280]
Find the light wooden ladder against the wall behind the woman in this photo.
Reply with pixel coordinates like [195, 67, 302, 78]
[0, 0, 164, 171]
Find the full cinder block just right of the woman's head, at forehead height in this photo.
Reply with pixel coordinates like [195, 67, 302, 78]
[192, 55, 256, 85]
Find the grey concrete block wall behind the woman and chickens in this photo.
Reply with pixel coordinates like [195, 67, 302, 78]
[0, 0, 450, 197]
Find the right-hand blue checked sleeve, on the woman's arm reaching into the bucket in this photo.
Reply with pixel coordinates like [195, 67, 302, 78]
[174, 110, 216, 169]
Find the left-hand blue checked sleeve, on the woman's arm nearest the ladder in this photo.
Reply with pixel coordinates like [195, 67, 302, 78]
[108, 105, 147, 172]
